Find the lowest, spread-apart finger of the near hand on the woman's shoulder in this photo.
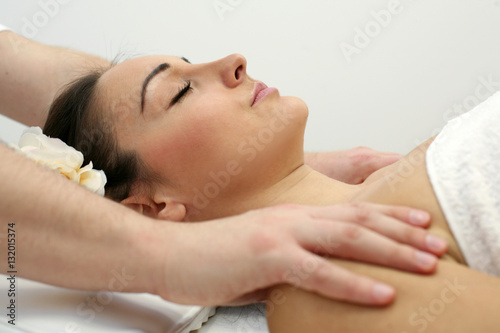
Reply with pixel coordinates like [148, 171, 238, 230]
[283, 251, 396, 305]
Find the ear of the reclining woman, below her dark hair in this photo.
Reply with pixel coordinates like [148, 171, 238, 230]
[121, 195, 186, 222]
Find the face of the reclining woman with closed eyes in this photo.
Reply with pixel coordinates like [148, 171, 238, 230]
[99, 55, 307, 219]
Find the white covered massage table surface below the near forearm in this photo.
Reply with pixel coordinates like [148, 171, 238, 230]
[0, 275, 215, 333]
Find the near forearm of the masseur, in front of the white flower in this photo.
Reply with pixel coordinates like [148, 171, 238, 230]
[0, 145, 170, 293]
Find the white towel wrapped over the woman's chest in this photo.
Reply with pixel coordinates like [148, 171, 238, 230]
[427, 92, 500, 276]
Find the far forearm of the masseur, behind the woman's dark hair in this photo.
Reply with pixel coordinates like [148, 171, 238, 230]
[0, 31, 109, 127]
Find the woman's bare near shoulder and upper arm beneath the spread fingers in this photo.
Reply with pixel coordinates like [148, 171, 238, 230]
[268, 259, 500, 333]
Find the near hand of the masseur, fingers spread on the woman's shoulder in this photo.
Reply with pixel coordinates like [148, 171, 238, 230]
[155, 204, 446, 305]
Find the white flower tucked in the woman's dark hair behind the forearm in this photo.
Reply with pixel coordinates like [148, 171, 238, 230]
[9, 127, 107, 196]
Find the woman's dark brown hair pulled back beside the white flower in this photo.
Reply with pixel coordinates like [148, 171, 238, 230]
[43, 68, 144, 201]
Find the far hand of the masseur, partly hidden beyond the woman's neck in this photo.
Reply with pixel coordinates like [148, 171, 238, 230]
[305, 147, 402, 184]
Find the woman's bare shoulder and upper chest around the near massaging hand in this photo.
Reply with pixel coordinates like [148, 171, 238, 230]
[268, 139, 500, 333]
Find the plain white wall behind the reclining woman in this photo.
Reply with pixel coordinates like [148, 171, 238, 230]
[0, 0, 500, 153]
